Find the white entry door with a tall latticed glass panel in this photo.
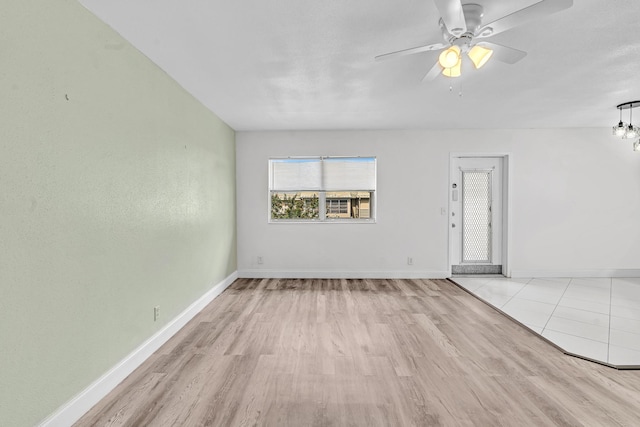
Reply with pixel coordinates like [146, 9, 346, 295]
[449, 157, 503, 274]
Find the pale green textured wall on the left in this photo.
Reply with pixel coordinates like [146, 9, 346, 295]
[0, 0, 236, 427]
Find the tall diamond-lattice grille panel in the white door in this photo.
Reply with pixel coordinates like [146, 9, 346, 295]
[462, 170, 493, 263]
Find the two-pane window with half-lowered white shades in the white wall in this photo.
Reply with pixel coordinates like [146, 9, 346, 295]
[269, 157, 376, 222]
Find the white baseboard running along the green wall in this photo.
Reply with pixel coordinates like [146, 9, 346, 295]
[40, 271, 238, 427]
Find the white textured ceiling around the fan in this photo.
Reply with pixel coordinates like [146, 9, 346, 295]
[80, 0, 640, 131]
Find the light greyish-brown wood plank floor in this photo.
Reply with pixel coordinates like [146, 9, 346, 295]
[77, 279, 640, 426]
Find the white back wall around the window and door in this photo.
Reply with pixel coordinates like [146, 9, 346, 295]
[236, 129, 640, 277]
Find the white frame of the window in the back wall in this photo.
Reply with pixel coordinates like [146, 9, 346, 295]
[267, 156, 378, 224]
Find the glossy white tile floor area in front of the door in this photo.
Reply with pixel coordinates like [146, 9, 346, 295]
[452, 276, 640, 368]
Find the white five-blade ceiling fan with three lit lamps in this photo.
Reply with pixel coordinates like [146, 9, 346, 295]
[375, 0, 573, 81]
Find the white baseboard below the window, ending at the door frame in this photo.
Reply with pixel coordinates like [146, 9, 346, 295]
[238, 269, 451, 279]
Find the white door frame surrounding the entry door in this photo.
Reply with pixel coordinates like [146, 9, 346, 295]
[446, 152, 513, 277]
